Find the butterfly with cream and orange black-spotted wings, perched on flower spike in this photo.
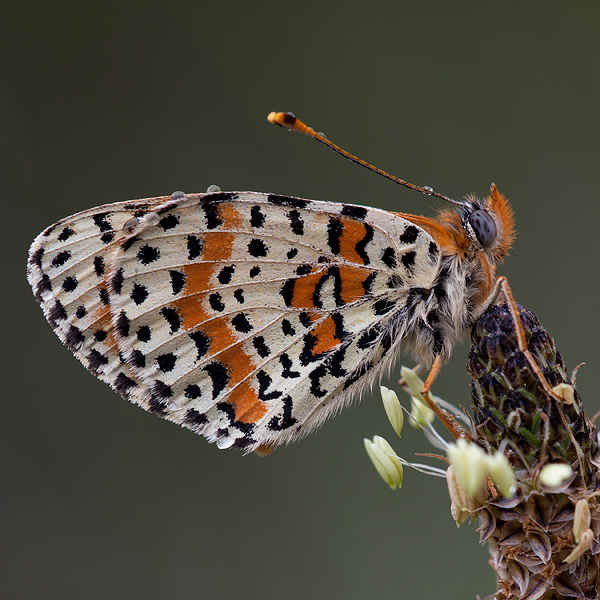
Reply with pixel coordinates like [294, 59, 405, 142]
[27, 113, 514, 454]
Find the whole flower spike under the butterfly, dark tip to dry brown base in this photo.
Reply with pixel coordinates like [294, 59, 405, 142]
[468, 305, 600, 600]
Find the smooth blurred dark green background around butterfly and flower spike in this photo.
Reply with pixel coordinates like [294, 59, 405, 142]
[0, 0, 600, 600]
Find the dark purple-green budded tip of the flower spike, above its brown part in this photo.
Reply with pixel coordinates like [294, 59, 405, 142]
[468, 305, 598, 485]
